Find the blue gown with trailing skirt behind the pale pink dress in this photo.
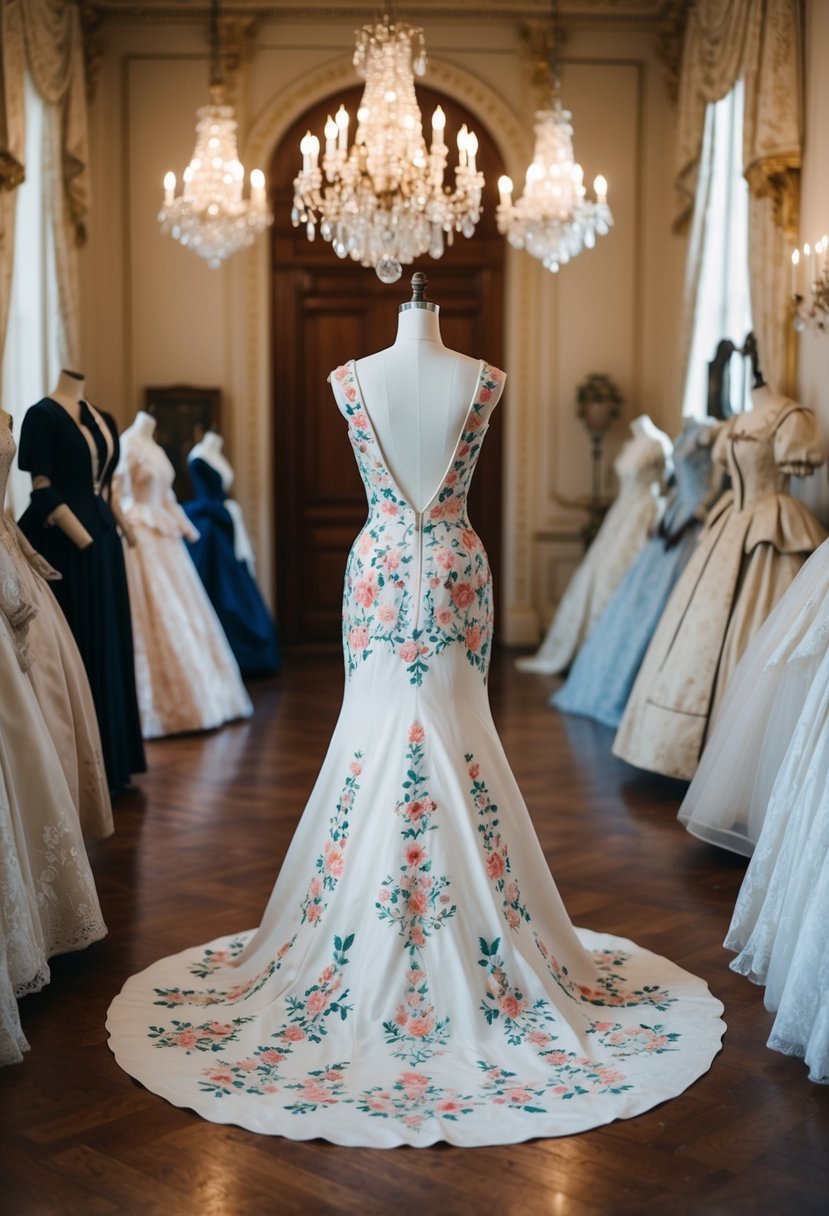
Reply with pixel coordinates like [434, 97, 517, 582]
[182, 456, 280, 676]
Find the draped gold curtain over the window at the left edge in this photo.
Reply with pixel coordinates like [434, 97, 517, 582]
[0, 0, 90, 366]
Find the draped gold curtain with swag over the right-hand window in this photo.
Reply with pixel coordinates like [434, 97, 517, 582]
[675, 0, 802, 390]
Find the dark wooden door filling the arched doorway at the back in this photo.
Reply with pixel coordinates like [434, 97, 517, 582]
[269, 86, 504, 643]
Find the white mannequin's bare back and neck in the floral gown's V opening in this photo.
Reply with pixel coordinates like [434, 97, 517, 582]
[347, 274, 481, 511]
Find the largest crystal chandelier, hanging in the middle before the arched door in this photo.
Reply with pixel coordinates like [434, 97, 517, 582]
[291, 16, 484, 283]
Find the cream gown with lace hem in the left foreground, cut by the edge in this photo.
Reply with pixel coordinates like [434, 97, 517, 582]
[0, 545, 107, 1063]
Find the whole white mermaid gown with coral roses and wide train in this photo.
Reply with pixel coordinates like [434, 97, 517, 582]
[108, 362, 723, 1148]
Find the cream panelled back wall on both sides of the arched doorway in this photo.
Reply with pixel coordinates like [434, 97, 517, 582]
[77, 18, 684, 642]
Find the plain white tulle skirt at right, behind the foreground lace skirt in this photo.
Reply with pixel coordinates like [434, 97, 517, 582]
[678, 541, 829, 857]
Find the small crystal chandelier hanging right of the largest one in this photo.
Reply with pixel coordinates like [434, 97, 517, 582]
[496, 4, 613, 274]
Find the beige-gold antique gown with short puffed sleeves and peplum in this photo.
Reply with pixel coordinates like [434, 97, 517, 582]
[613, 385, 825, 781]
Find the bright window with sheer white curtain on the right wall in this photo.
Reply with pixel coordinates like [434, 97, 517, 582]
[682, 81, 751, 418]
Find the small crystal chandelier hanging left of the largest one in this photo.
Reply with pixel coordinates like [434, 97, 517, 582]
[158, 0, 273, 269]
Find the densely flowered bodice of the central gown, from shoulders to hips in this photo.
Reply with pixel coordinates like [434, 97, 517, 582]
[332, 361, 504, 687]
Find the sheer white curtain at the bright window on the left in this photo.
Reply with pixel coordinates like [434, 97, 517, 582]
[2, 71, 62, 516]
